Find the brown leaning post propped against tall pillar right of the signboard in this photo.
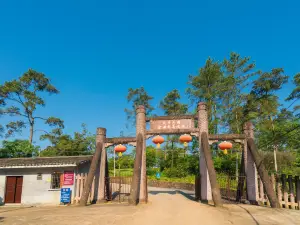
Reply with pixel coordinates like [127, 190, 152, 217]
[201, 132, 222, 207]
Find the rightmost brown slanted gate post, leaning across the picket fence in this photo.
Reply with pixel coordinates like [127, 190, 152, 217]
[247, 138, 280, 208]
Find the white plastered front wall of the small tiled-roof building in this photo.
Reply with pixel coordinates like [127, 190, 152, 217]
[0, 167, 75, 205]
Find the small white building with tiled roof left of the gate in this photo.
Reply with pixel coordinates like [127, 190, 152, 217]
[0, 156, 92, 205]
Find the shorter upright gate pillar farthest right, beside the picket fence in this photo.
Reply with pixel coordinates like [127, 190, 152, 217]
[244, 122, 259, 204]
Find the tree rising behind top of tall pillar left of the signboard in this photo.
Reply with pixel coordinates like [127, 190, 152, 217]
[125, 87, 154, 125]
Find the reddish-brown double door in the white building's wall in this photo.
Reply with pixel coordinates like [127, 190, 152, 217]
[5, 177, 23, 203]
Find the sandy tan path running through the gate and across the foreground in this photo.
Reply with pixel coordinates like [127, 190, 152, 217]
[0, 188, 300, 225]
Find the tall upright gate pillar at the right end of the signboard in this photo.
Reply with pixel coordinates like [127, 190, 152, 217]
[198, 102, 212, 202]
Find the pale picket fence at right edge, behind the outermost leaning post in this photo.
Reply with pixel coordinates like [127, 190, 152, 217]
[258, 174, 300, 210]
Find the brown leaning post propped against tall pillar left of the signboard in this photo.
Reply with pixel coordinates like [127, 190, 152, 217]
[129, 134, 144, 205]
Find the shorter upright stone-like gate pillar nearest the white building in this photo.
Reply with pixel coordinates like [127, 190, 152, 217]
[96, 129, 108, 202]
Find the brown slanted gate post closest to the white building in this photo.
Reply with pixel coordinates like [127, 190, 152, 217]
[80, 128, 106, 206]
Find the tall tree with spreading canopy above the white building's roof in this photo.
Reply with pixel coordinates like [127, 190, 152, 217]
[0, 69, 64, 144]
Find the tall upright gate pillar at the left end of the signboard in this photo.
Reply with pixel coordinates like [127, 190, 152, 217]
[136, 105, 148, 203]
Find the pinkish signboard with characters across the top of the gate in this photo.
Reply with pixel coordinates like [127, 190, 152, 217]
[150, 119, 194, 130]
